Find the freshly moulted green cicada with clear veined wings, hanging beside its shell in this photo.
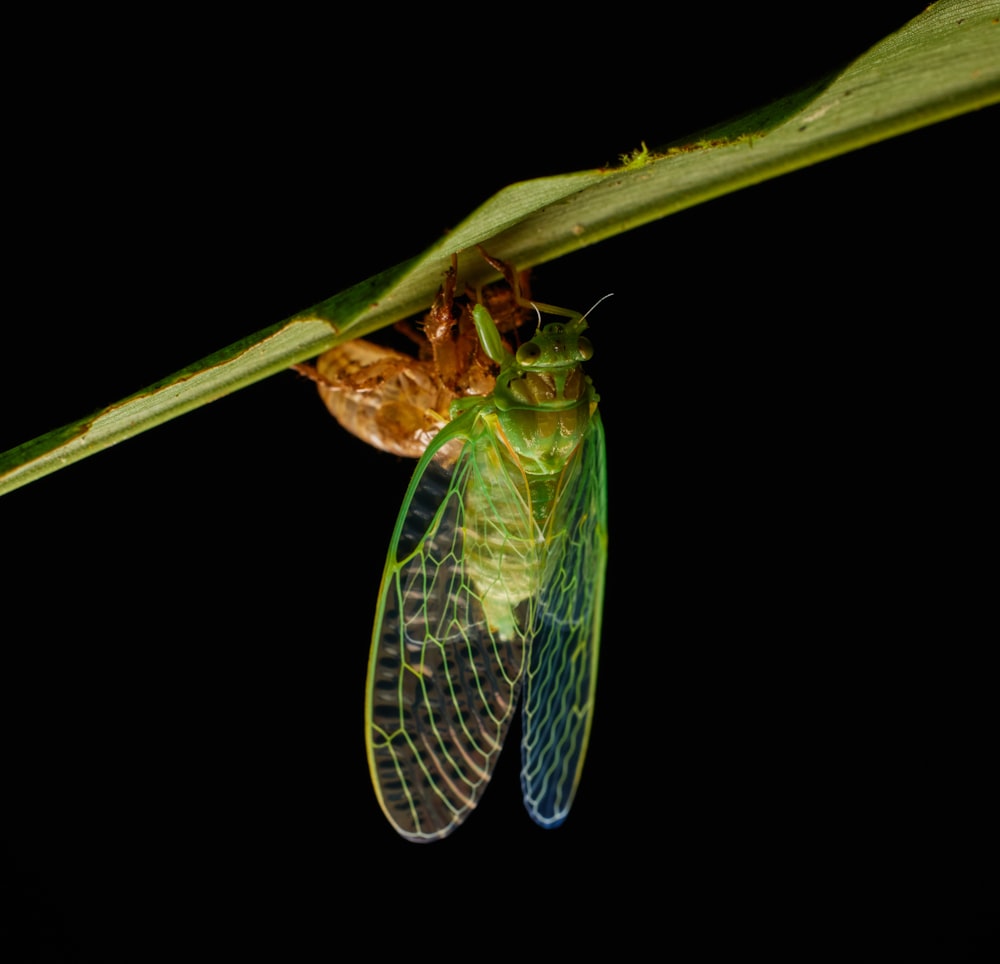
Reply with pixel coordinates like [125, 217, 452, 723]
[365, 290, 607, 842]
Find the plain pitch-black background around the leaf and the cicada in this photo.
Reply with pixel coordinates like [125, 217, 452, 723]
[0, 3, 998, 960]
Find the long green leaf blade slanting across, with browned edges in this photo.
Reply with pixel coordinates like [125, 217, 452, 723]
[0, 0, 1000, 494]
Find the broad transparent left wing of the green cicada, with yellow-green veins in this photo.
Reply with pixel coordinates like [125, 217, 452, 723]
[365, 410, 537, 841]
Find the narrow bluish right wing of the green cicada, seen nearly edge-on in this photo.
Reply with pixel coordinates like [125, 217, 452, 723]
[521, 412, 608, 827]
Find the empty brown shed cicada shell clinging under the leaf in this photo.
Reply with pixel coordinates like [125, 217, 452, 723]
[294, 259, 531, 458]
